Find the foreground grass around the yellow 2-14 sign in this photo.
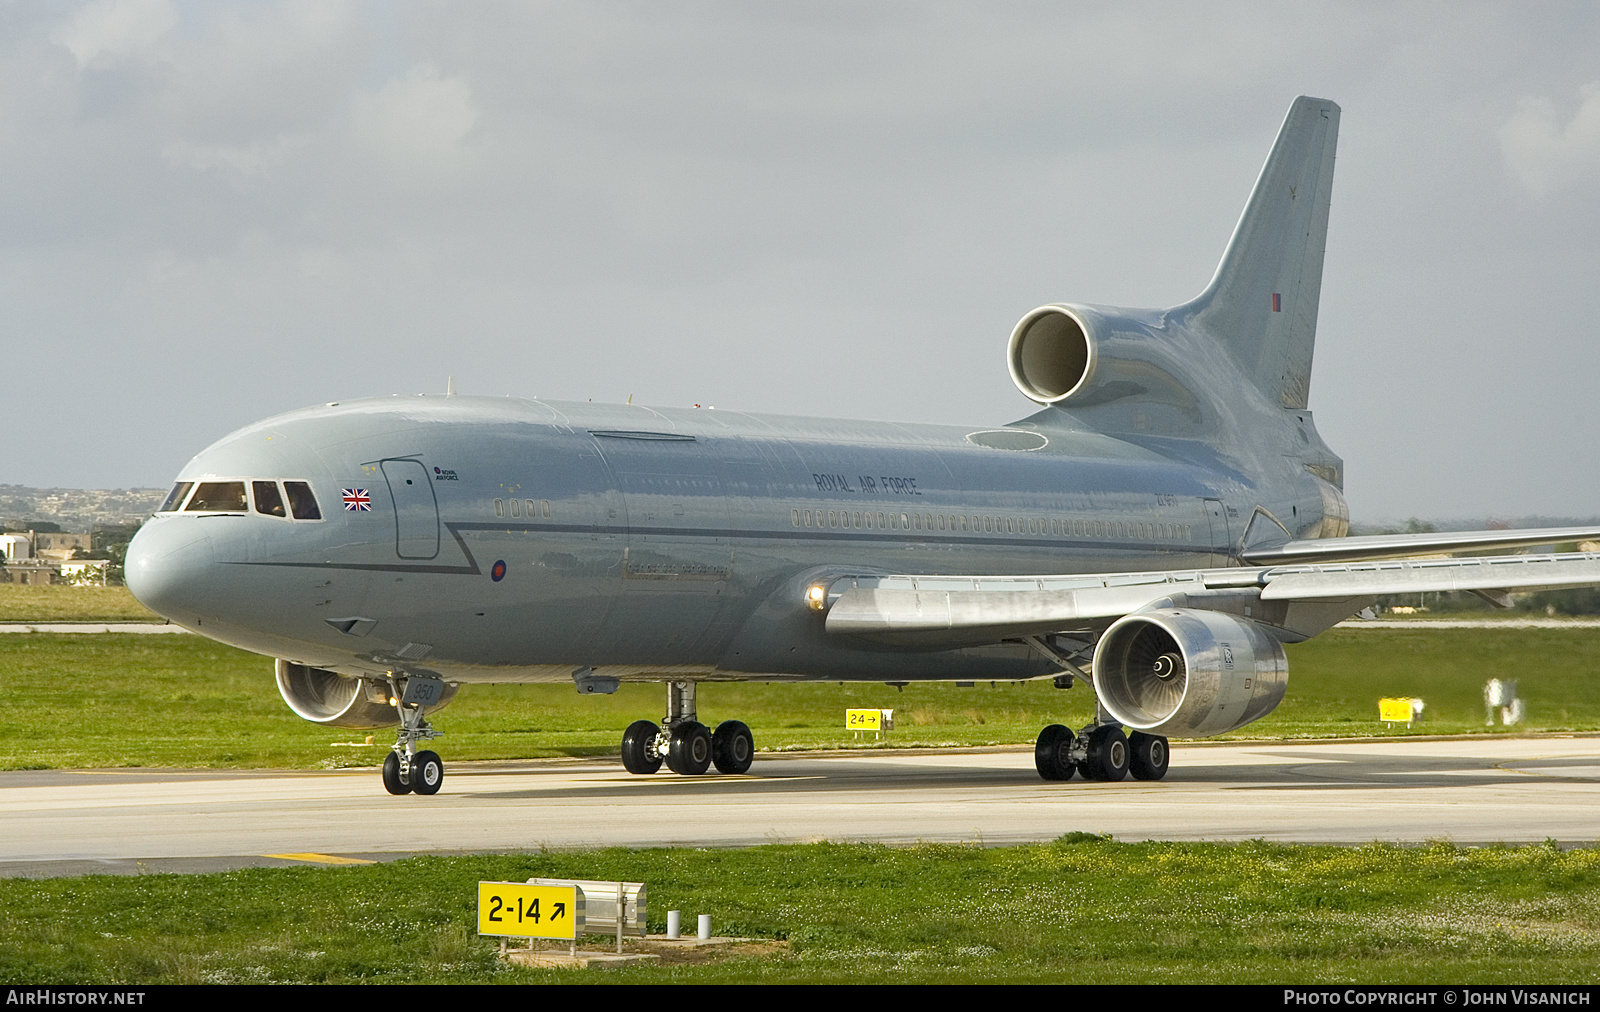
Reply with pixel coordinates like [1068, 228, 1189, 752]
[0, 834, 1600, 985]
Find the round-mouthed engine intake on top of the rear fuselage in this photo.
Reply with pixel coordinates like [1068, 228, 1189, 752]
[1006, 303, 1203, 432]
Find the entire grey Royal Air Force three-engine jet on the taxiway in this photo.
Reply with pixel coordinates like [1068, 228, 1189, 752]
[128, 98, 1600, 794]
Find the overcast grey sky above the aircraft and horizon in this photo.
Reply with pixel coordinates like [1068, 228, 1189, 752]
[0, 0, 1600, 520]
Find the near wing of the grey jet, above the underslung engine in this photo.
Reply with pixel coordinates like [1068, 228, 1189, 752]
[826, 552, 1600, 647]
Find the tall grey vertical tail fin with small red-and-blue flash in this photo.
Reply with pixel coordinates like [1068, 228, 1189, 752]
[1186, 96, 1339, 408]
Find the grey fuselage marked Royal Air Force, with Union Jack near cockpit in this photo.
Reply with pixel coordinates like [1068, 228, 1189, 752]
[136, 396, 1325, 682]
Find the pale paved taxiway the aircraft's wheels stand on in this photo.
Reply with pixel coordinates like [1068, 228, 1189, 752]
[0, 737, 1600, 876]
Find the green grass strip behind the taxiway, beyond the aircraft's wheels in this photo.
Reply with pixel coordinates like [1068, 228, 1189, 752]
[0, 628, 1600, 769]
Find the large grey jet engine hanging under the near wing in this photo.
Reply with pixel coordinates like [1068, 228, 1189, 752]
[1094, 608, 1288, 738]
